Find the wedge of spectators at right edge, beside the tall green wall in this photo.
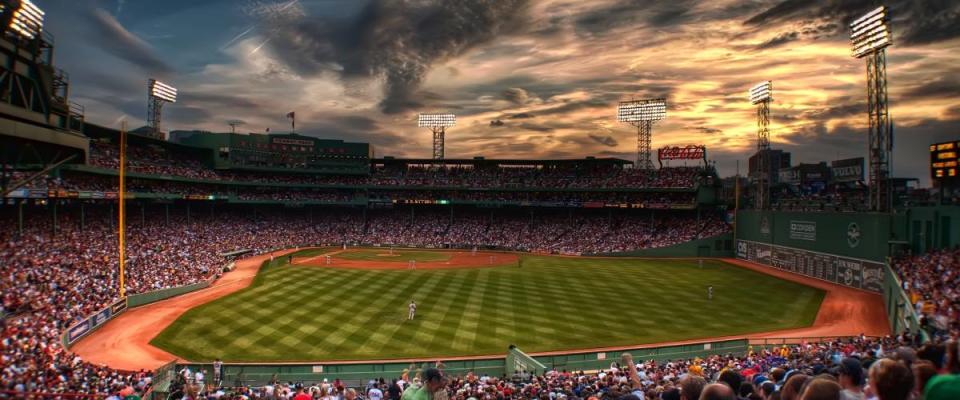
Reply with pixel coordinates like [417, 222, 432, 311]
[894, 248, 960, 337]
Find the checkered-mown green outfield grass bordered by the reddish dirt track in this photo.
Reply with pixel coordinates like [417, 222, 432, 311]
[151, 250, 824, 362]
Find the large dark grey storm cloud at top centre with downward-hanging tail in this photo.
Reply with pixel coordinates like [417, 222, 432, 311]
[254, 0, 527, 113]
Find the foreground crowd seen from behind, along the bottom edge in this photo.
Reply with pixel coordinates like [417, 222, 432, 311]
[199, 335, 960, 400]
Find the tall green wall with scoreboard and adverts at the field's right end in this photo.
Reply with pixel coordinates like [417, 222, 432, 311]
[735, 206, 960, 340]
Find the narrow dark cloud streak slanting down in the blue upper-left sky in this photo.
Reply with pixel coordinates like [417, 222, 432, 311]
[86, 8, 173, 77]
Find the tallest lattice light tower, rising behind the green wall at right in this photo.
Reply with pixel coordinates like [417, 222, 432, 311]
[850, 6, 893, 212]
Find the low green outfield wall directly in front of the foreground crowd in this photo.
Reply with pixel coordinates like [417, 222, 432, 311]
[178, 339, 748, 386]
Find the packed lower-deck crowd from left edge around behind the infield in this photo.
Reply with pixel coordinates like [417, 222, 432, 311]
[0, 206, 721, 393]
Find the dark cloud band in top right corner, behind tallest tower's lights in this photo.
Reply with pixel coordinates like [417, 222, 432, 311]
[744, 0, 960, 44]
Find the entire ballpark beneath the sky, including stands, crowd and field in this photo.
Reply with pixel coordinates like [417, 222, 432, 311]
[0, 0, 960, 400]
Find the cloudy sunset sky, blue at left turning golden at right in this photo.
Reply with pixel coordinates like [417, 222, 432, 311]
[35, 0, 960, 185]
